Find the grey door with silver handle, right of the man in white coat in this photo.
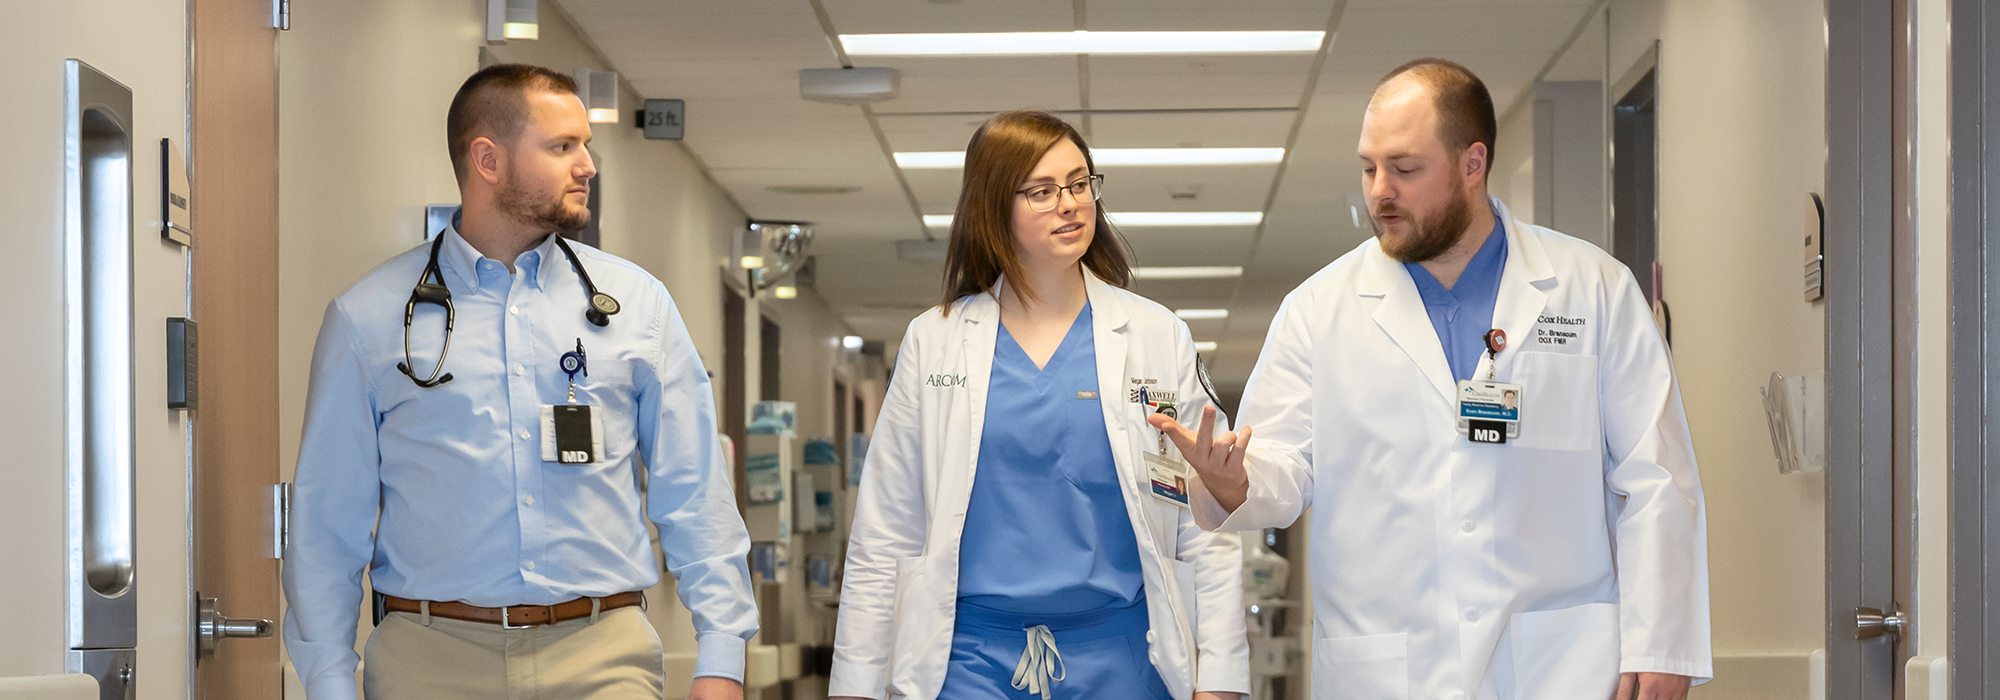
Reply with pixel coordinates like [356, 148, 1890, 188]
[1824, 0, 1920, 700]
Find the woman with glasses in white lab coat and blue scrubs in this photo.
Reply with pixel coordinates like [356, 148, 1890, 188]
[828, 112, 1250, 700]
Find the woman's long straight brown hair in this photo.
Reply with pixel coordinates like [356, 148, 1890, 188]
[942, 110, 1132, 314]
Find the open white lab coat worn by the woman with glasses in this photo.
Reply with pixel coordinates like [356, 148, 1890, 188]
[828, 272, 1250, 698]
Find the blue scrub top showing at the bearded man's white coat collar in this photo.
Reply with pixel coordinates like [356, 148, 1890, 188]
[1402, 212, 1506, 382]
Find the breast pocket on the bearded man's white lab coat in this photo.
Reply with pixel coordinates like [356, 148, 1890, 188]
[1514, 352, 1604, 452]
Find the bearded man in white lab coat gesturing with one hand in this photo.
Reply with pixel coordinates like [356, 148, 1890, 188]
[1152, 60, 1712, 700]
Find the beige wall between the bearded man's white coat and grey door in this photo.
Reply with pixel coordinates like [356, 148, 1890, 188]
[1608, 0, 1826, 698]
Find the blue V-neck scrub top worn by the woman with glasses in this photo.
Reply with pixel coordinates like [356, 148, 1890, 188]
[958, 304, 1144, 614]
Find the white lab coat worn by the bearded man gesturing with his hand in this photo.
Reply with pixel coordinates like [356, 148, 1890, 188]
[1194, 198, 1712, 700]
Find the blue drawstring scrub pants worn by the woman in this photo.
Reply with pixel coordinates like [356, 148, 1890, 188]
[938, 598, 1172, 700]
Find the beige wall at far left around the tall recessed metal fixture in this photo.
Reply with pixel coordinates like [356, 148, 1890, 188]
[0, 0, 190, 698]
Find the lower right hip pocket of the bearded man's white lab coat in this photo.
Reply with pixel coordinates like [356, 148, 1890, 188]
[1506, 602, 1618, 700]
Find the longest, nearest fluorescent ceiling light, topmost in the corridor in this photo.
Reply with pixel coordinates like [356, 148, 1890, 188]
[840, 32, 1326, 56]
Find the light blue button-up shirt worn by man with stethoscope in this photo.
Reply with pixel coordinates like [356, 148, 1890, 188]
[284, 230, 758, 700]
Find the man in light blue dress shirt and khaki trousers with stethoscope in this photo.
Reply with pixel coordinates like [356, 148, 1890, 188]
[284, 66, 758, 700]
